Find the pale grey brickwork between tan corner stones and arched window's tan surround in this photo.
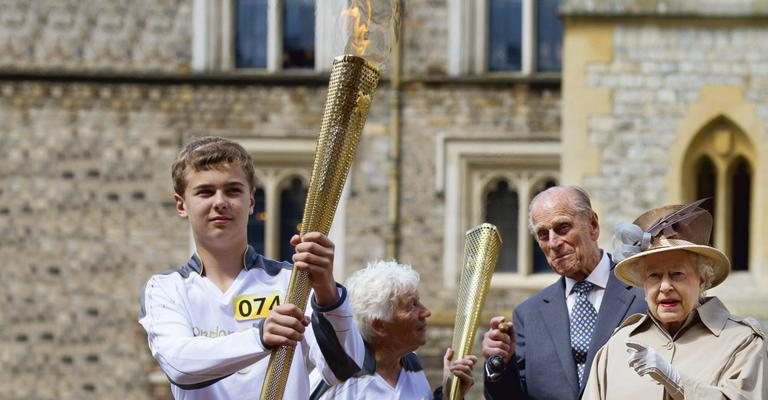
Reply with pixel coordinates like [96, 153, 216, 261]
[585, 22, 768, 231]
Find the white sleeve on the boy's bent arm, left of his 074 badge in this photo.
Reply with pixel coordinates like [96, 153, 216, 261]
[139, 276, 270, 388]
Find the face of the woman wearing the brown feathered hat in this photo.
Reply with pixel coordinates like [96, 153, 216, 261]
[643, 250, 704, 334]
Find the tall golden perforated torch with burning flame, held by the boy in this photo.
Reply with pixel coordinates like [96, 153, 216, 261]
[261, 0, 395, 400]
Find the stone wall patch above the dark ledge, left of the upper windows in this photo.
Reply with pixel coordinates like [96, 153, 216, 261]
[0, 0, 192, 73]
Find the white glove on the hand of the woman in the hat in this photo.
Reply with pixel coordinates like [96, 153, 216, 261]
[627, 340, 684, 399]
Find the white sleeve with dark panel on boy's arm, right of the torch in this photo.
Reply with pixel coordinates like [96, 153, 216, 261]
[307, 284, 365, 385]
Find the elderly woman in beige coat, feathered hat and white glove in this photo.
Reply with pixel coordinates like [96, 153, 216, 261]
[582, 201, 768, 399]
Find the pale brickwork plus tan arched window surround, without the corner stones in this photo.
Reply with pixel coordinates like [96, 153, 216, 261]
[583, 18, 768, 325]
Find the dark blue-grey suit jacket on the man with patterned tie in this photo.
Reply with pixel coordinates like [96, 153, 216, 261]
[485, 265, 647, 400]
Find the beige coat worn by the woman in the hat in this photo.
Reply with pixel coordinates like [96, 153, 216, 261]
[582, 297, 768, 400]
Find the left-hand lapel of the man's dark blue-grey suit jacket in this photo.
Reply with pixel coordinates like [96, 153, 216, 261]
[539, 277, 579, 392]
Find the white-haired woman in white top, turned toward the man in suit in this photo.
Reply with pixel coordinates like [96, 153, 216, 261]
[310, 261, 477, 400]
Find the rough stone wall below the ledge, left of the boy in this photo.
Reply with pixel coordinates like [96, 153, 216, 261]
[0, 81, 183, 399]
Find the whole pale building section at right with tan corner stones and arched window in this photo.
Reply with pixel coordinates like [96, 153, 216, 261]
[562, 1, 768, 321]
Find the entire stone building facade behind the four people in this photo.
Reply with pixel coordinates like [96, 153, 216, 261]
[0, 0, 768, 399]
